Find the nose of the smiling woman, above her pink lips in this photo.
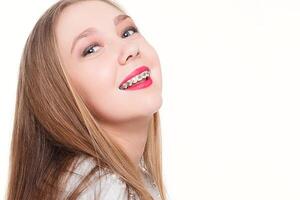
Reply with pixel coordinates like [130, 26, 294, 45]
[118, 43, 140, 65]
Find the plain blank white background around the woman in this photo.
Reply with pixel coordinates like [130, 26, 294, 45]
[0, 0, 300, 200]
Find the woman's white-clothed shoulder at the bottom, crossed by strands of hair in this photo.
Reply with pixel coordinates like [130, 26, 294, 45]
[65, 157, 128, 200]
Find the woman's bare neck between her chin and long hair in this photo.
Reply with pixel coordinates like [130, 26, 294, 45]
[100, 117, 151, 167]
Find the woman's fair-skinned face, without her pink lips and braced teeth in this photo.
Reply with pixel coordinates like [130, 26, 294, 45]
[55, 1, 162, 123]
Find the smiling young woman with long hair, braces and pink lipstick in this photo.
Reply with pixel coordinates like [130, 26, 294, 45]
[7, 0, 166, 200]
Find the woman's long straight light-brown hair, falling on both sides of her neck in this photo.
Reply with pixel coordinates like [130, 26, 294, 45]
[7, 0, 166, 200]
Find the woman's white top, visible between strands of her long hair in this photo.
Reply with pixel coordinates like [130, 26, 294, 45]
[65, 157, 161, 200]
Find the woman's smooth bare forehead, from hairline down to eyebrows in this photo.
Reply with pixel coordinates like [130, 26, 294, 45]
[55, 0, 123, 40]
